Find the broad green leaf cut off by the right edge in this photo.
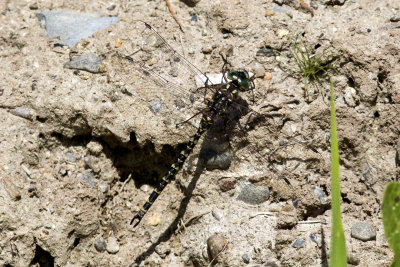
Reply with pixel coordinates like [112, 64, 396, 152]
[382, 182, 400, 267]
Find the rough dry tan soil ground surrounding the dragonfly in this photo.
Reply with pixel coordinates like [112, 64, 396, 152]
[0, 0, 400, 266]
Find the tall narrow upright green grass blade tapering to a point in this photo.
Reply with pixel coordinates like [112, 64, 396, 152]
[329, 79, 347, 267]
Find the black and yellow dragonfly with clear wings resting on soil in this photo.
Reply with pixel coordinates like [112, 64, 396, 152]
[111, 21, 304, 227]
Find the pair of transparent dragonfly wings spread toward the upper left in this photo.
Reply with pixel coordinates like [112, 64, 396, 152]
[119, 22, 212, 103]
